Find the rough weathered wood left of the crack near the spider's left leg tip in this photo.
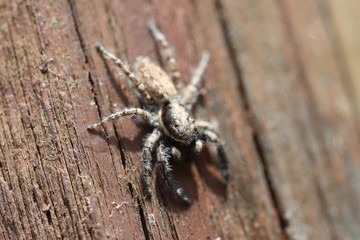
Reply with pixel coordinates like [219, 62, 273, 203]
[1, 1, 144, 239]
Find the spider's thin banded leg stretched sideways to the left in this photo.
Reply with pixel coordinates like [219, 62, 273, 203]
[87, 108, 154, 130]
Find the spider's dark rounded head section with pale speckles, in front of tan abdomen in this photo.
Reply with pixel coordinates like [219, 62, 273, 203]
[159, 103, 198, 144]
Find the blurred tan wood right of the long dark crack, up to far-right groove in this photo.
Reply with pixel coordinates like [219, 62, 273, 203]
[219, 1, 359, 239]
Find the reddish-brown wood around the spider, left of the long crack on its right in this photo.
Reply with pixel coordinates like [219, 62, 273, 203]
[1, 1, 279, 239]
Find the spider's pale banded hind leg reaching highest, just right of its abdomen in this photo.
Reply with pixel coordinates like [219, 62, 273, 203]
[148, 22, 182, 89]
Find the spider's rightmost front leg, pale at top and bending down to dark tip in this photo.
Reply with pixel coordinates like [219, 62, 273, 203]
[200, 128, 230, 182]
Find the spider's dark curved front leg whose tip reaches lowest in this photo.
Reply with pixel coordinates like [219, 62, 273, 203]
[157, 144, 191, 204]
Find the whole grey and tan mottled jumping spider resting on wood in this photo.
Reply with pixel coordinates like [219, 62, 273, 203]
[87, 22, 229, 203]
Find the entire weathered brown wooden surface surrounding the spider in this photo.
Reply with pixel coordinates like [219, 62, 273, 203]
[0, 0, 360, 240]
